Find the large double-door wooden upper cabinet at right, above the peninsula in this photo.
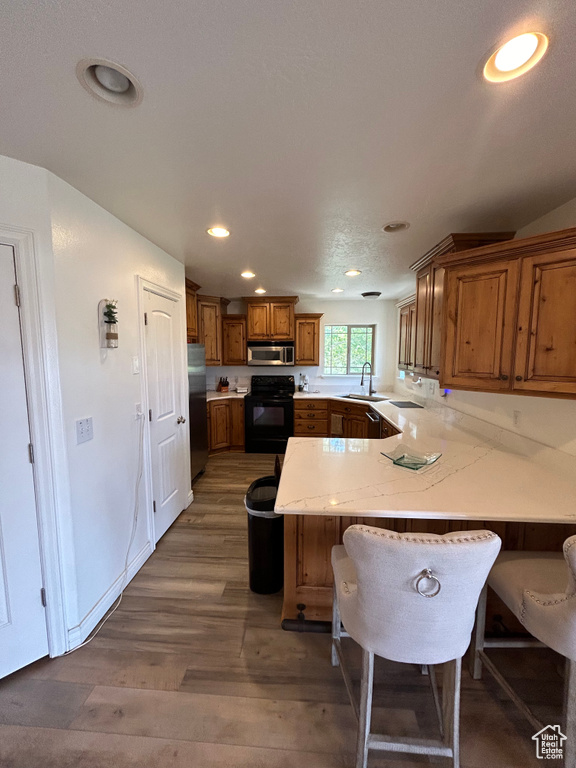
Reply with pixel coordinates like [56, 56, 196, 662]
[441, 229, 576, 397]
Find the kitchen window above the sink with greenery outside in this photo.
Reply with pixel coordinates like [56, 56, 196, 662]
[323, 325, 376, 376]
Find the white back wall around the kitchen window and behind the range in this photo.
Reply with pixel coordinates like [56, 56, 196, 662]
[206, 299, 396, 393]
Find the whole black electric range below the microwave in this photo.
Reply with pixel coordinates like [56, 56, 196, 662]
[244, 376, 294, 453]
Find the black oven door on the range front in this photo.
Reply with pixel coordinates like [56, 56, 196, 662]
[244, 396, 294, 453]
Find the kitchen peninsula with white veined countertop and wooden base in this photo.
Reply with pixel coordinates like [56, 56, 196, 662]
[276, 394, 576, 621]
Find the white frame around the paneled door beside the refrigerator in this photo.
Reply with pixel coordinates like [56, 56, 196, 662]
[136, 275, 194, 550]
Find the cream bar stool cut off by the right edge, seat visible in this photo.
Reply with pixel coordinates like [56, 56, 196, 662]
[471, 536, 576, 768]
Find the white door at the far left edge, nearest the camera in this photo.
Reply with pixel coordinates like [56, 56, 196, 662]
[0, 244, 48, 677]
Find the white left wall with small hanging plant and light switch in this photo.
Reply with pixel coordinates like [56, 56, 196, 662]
[48, 174, 185, 634]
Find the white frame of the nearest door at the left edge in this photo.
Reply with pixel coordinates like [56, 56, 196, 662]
[0, 224, 71, 657]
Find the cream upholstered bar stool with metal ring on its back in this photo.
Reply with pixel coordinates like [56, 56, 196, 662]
[332, 525, 501, 768]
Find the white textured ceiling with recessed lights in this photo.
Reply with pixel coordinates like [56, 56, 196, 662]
[0, 0, 576, 298]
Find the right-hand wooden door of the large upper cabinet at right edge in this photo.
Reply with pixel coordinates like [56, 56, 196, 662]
[512, 250, 576, 394]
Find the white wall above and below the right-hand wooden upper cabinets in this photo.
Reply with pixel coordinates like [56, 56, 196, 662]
[396, 198, 576, 455]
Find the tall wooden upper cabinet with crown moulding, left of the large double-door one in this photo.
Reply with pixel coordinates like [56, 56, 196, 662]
[406, 232, 514, 379]
